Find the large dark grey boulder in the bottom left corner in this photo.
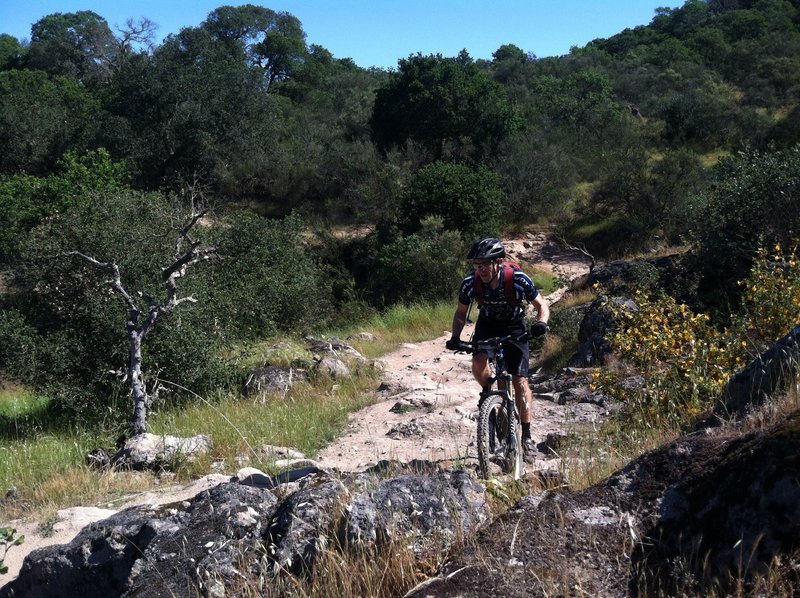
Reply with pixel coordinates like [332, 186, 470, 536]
[0, 483, 277, 598]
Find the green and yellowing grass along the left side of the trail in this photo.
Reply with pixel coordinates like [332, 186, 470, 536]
[0, 302, 455, 522]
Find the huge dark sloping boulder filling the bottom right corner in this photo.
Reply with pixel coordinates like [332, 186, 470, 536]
[407, 412, 800, 598]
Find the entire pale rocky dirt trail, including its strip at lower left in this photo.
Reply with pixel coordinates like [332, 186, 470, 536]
[0, 233, 605, 586]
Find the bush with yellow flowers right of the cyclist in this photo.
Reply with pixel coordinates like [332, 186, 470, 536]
[593, 241, 800, 425]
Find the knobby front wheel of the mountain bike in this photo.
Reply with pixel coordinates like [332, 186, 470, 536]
[478, 392, 522, 480]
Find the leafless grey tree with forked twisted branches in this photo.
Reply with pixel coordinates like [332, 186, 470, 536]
[64, 199, 216, 435]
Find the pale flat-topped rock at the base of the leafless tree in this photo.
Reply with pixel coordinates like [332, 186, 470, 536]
[111, 433, 211, 469]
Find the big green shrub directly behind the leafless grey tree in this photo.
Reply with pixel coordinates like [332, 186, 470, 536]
[2, 191, 221, 418]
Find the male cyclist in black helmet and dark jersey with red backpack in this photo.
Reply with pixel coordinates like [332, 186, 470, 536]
[445, 237, 550, 456]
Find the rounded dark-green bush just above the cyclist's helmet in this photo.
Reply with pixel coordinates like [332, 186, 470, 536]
[400, 162, 510, 240]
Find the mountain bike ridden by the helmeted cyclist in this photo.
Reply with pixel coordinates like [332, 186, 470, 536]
[457, 333, 528, 480]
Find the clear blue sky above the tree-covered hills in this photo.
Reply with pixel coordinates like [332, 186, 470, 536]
[0, 0, 683, 68]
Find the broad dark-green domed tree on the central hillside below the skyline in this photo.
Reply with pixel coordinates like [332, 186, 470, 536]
[371, 52, 521, 161]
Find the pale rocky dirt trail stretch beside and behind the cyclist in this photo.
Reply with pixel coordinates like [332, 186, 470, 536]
[317, 233, 589, 471]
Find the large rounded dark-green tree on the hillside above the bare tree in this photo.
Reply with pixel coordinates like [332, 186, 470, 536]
[107, 28, 276, 188]
